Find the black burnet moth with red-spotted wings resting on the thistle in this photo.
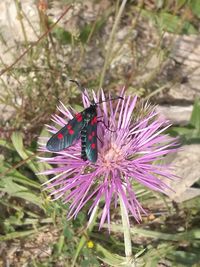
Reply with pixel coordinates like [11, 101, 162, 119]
[46, 80, 123, 163]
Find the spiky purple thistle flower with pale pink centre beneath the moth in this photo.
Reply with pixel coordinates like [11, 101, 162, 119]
[40, 89, 176, 227]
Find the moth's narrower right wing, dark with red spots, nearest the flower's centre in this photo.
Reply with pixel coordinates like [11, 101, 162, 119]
[85, 116, 98, 162]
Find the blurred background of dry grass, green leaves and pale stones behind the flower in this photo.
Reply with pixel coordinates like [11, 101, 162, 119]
[0, 0, 200, 267]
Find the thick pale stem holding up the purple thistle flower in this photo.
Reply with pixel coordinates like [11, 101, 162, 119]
[120, 196, 135, 267]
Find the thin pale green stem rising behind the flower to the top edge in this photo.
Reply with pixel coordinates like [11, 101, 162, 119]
[99, 0, 127, 88]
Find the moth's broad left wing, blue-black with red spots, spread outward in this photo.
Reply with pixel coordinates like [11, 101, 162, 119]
[46, 113, 84, 152]
